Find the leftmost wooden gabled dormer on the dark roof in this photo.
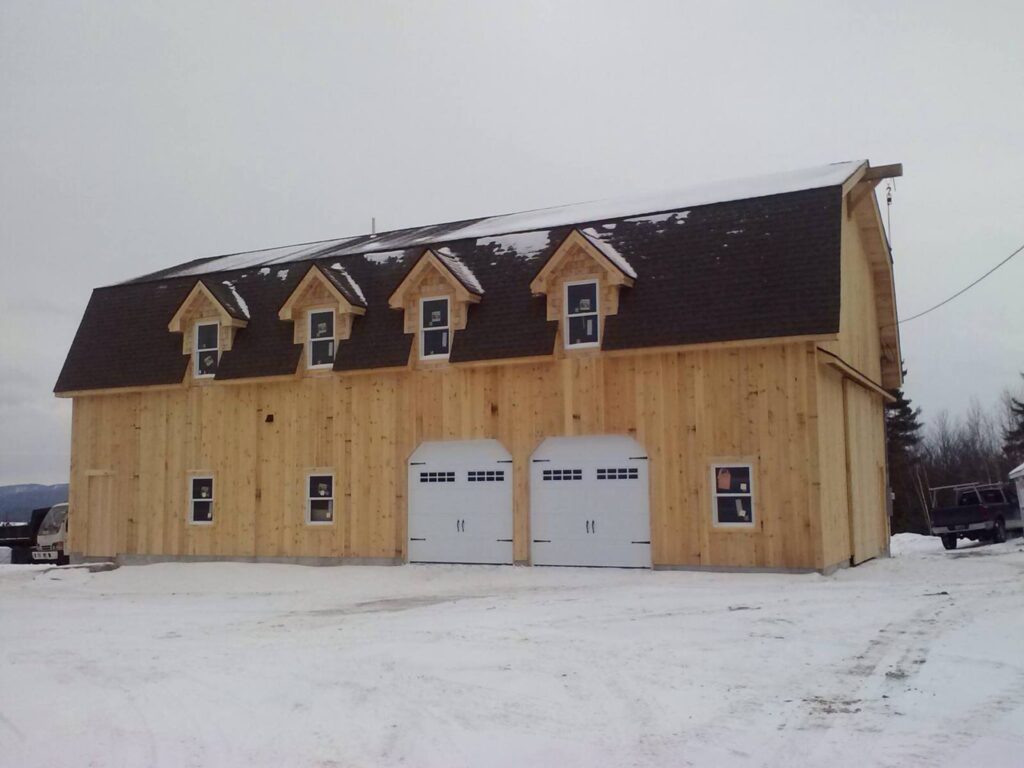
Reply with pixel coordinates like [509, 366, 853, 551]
[167, 279, 249, 379]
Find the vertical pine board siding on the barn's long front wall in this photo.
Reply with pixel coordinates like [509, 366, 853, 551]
[71, 342, 829, 568]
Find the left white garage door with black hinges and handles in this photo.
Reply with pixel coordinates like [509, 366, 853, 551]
[409, 440, 512, 564]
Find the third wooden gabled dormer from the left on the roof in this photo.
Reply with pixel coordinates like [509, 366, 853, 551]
[388, 248, 483, 364]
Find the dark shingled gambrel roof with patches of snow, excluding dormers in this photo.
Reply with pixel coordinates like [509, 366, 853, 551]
[56, 162, 888, 392]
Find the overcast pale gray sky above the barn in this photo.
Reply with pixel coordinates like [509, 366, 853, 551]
[0, 0, 1024, 483]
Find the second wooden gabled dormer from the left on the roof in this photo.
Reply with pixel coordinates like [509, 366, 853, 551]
[278, 263, 367, 371]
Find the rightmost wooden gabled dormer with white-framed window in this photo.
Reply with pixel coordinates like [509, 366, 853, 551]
[529, 227, 637, 352]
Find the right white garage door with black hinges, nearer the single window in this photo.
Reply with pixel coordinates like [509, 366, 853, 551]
[529, 435, 650, 568]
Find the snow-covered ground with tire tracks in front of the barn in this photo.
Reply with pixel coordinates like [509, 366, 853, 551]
[0, 536, 1024, 768]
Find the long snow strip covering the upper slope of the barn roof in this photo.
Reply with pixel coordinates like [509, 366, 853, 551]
[128, 160, 866, 280]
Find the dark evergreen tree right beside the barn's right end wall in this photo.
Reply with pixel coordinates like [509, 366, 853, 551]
[886, 382, 928, 534]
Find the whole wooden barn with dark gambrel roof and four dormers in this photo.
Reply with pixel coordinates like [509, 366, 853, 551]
[55, 162, 900, 570]
